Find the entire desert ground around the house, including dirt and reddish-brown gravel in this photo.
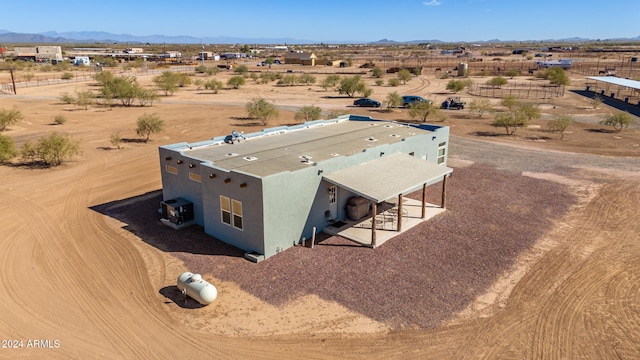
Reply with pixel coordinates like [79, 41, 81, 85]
[0, 51, 640, 359]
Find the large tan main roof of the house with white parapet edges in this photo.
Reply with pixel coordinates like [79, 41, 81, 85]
[170, 116, 440, 177]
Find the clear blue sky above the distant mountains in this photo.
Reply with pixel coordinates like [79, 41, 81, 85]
[0, 0, 640, 42]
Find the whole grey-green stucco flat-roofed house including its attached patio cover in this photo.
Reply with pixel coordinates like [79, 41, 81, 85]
[159, 115, 453, 261]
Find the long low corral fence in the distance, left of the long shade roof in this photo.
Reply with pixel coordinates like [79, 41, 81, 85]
[468, 83, 564, 99]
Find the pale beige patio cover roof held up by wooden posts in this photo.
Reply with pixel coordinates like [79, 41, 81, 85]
[324, 153, 453, 203]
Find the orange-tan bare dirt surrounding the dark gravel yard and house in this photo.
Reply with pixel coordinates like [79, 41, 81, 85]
[0, 66, 640, 359]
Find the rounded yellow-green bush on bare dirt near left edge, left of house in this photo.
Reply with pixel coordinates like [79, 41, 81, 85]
[21, 132, 80, 166]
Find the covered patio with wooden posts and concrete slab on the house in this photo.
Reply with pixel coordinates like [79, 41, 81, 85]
[324, 153, 453, 248]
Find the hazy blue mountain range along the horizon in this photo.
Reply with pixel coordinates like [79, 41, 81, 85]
[0, 30, 640, 45]
